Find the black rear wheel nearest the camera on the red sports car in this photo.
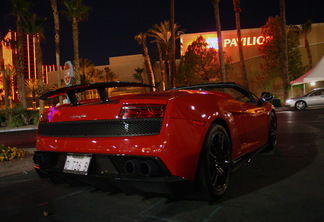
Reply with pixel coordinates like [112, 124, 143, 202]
[198, 124, 231, 200]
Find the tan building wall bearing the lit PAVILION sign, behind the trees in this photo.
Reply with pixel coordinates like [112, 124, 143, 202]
[180, 23, 324, 98]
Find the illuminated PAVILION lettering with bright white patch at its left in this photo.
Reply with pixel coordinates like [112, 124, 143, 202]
[206, 36, 271, 49]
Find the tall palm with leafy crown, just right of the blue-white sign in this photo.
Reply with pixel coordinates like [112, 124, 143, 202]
[63, 0, 91, 84]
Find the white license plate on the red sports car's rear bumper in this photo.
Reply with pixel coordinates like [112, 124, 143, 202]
[63, 154, 91, 175]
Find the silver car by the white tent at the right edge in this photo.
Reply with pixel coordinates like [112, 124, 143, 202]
[285, 88, 324, 110]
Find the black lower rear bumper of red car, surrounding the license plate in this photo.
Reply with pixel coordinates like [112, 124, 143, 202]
[34, 151, 195, 196]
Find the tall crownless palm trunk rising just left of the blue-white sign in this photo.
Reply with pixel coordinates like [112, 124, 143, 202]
[51, 0, 62, 91]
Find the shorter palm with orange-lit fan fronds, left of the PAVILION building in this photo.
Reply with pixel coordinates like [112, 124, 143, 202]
[148, 21, 179, 90]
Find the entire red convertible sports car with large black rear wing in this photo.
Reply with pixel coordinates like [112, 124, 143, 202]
[34, 82, 277, 200]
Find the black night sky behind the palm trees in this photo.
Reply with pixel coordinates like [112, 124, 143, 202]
[0, 0, 324, 65]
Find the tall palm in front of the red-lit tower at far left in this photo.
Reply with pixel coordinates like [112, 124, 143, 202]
[11, 0, 30, 109]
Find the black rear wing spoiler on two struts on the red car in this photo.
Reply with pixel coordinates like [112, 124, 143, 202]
[39, 82, 153, 106]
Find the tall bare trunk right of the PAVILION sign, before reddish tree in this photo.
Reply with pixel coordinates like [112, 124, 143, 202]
[280, 0, 289, 100]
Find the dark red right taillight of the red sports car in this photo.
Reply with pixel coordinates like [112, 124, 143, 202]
[119, 105, 165, 119]
